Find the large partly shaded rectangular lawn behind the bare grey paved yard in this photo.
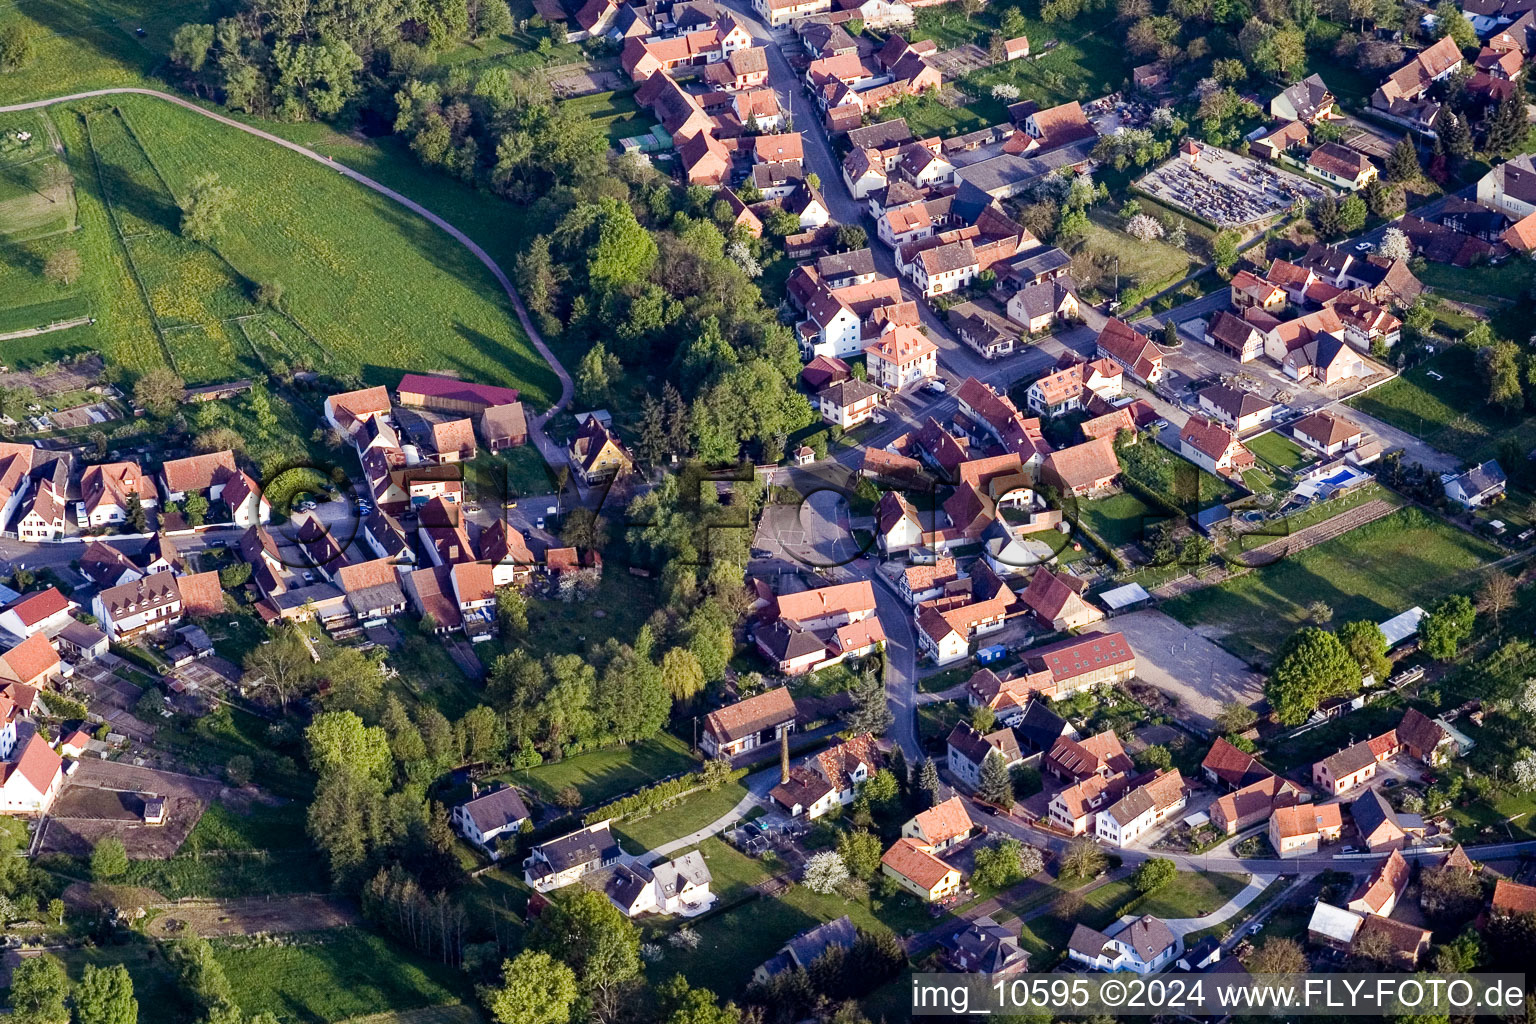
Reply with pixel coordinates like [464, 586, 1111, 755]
[1163, 510, 1498, 662]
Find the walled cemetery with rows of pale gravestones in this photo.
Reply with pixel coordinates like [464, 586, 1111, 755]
[1137, 143, 1329, 227]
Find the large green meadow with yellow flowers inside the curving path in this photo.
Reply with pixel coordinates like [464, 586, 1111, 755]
[0, 98, 558, 405]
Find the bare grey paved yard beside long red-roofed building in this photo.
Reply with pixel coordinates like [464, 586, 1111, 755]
[1098, 609, 1264, 732]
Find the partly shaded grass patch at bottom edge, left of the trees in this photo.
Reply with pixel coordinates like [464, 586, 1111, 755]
[214, 927, 470, 1024]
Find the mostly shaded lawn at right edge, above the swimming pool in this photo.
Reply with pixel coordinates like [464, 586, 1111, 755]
[1350, 345, 1536, 464]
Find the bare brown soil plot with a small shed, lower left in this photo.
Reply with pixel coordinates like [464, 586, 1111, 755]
[38, 758, 223, 860]
